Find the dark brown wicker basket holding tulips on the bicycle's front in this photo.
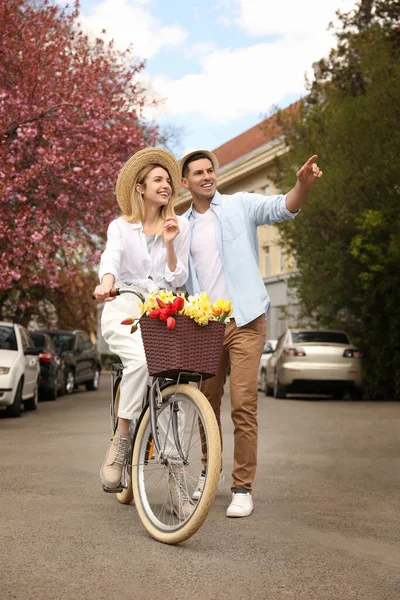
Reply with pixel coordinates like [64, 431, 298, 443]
[140, 315, 225, 379]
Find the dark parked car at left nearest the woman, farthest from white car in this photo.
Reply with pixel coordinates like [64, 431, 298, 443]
[35, 329, 101, 394]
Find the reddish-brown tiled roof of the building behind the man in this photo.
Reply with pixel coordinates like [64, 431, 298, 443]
[213, 101, 300, 167]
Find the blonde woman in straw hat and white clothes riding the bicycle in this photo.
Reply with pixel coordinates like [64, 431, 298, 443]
[94, 148, 189, 496]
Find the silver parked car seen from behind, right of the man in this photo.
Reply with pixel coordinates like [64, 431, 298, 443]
[266, 329, 362, 399]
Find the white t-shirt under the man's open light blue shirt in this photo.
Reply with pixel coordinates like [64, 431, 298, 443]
[191, 208, 229, 302]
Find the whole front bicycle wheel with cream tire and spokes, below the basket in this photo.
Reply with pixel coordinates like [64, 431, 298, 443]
[132, 384, 221, 544]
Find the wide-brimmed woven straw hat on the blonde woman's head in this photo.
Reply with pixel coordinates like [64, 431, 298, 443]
[116, 148, 181, 215]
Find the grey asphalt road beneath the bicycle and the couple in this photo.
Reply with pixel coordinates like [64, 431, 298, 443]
[0, 376, 400, 600]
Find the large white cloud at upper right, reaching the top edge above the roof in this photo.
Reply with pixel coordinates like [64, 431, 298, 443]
[148, 0, 360, 124]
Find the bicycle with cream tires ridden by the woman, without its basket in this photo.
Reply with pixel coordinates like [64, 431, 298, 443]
[103, 288, 221, 544]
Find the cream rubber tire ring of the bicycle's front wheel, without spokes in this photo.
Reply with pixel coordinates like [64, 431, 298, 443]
[132, 384, 221, 544]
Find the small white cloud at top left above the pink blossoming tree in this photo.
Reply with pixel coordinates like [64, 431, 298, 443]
[81, 0, 188, 58]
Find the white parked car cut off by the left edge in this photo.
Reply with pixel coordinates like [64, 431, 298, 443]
[0, 321, 40, 417]
